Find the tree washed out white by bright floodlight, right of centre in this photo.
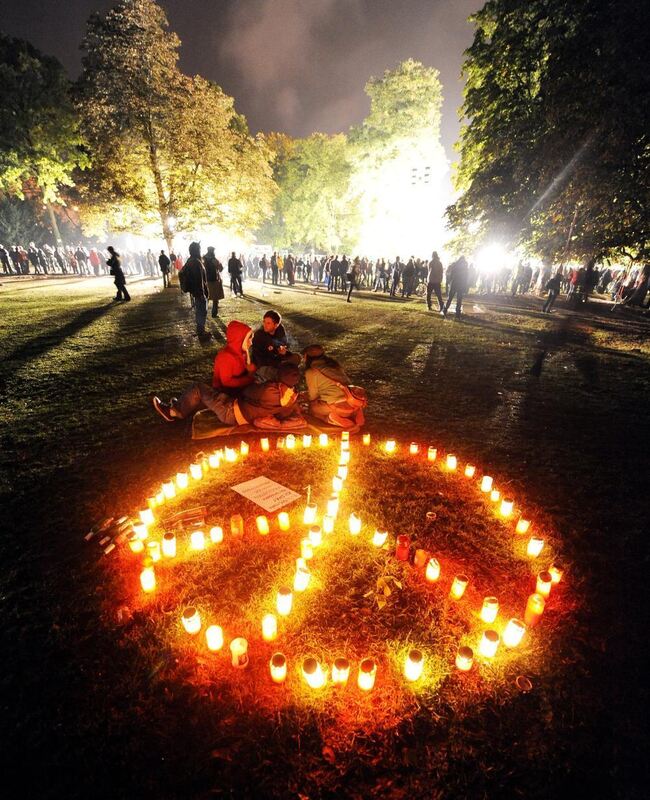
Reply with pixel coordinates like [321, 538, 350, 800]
[349, 60, 448, 255]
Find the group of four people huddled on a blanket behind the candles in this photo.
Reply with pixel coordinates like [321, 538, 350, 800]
[153, 310, 367, 430]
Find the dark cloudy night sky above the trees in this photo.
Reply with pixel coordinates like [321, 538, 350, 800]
[0, 0, 482, 157]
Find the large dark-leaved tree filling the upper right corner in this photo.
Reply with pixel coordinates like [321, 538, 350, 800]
[448, 0, 650, 259]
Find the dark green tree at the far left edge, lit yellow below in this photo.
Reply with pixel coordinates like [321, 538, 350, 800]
[0, 35, 88, 238]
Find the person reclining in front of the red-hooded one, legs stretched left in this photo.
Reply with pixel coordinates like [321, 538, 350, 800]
[153, 364, 305, 430]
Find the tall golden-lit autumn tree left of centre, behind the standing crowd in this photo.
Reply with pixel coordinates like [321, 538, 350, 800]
[78, 0, 275, 249]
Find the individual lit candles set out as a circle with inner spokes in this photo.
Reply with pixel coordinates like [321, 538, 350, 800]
[129, 432, 562, 690]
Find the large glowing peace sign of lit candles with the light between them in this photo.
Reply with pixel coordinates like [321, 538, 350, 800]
[109, 432, 563, 720]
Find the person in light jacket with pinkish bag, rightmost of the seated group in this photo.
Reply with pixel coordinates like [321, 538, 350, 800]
[302, 344, 366, 429]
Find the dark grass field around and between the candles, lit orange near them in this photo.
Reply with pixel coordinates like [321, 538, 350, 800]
[0, 278, 650, 798]
